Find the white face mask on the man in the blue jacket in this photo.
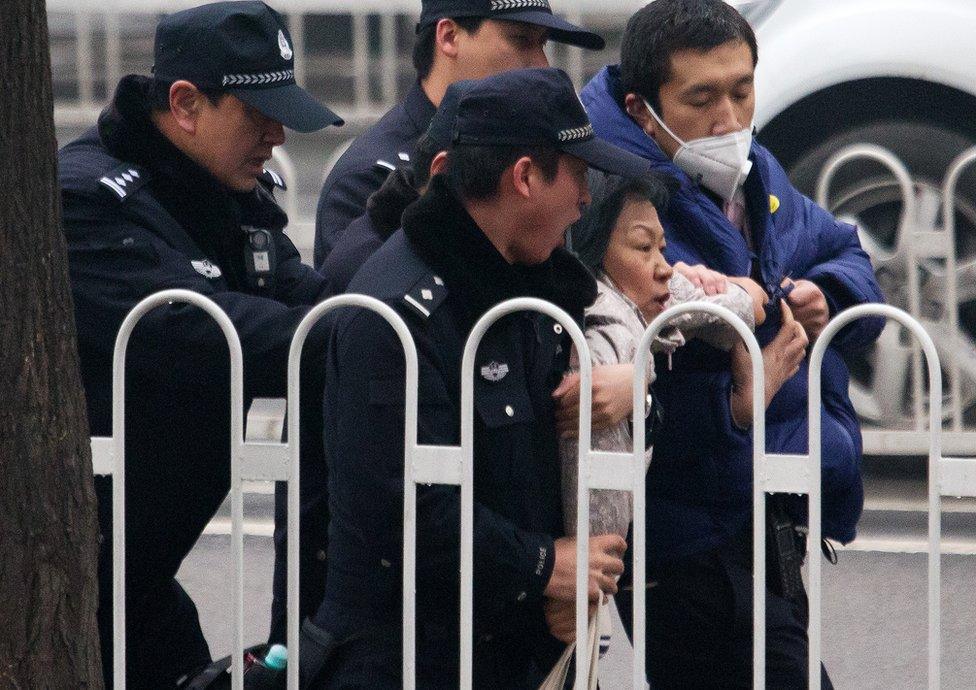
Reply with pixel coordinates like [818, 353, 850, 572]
[644, 100, 752, 201]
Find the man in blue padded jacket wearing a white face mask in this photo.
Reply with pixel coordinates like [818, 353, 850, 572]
[582, 0, 883, 687]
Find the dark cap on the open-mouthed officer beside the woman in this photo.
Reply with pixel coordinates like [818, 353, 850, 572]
[453, 67, 651, 177]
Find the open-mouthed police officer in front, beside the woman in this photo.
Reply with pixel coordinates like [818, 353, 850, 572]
[302, 68, 647, 688]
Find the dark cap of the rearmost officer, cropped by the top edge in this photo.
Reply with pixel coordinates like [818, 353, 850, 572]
[417, 0, 606, 50]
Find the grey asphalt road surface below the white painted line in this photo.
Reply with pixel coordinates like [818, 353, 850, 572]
[179, 536, 976, 689]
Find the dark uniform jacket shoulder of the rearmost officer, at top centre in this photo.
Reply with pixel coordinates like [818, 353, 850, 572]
[315, 83, 437, 270]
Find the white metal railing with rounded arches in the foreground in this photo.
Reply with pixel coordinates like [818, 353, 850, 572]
[86, 290, 976, 690]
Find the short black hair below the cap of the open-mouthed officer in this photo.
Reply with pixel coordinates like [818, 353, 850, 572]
[447, 146, 564, 201]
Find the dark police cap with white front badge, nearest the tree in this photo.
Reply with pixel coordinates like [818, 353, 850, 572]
[153, 0, 343, 132]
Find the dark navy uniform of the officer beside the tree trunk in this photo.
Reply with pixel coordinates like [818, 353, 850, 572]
[58, 76, 326, 687]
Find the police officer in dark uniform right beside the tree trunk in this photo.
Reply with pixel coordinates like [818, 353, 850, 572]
[59, 2, 341, 687]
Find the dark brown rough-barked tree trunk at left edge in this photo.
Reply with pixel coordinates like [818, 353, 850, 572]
[0, 0, 102, 688]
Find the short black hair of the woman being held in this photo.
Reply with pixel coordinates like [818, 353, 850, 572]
[570, 173, 678, 275]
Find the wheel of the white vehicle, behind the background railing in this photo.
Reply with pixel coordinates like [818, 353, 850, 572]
[790, 121, 976, 428]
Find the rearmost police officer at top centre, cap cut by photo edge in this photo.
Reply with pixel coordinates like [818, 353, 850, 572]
[315, 0, 604, 270]
